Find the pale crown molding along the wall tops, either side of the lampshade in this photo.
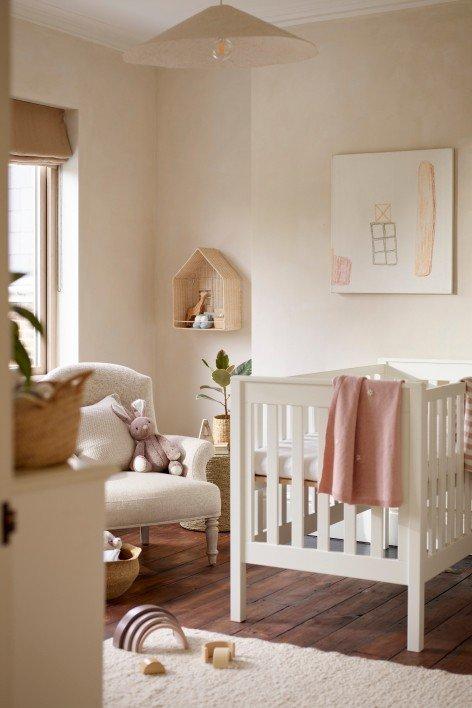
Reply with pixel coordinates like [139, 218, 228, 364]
[11, 0, 457, 51]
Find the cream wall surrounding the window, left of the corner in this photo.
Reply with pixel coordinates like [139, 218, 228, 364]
[11, 21, 157, 375]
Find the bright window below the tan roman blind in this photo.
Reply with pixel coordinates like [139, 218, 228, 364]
[8, 163, 58, 373]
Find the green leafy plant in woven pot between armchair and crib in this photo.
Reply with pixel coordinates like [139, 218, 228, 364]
[196, 349, 252, 445]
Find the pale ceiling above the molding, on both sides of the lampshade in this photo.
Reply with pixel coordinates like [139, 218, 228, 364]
[11, 0, 455, 49]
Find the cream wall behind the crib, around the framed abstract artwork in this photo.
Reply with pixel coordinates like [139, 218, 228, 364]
[252, 2, 472, 374]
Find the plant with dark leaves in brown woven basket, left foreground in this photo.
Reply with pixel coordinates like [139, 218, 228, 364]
[9, 273, 91, 469]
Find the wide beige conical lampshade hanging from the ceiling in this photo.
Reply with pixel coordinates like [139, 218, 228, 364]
[123, 5, 318, 69]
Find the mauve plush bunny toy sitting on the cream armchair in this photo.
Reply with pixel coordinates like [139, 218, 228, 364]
[112, 399, 183, 475]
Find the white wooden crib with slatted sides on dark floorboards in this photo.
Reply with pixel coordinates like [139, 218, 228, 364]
[231, 360, 472, 652]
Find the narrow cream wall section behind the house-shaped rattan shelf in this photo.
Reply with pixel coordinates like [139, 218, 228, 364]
[156, 70, 252, 435]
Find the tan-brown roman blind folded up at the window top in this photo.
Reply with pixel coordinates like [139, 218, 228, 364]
[10, 99, 72, 165]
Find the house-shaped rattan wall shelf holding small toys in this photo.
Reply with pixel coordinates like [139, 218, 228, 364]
[172, 247, 241, 332]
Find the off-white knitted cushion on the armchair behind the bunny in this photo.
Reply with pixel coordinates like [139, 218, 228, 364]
[77, 396, 135, 470]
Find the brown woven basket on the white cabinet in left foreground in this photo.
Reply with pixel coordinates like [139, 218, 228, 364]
[14, 371, 92, 469]
